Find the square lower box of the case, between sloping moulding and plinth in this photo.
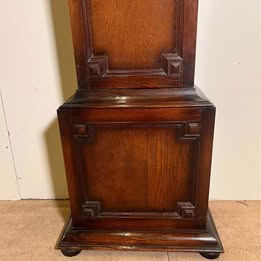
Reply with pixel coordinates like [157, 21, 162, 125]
[58, 102, 215, 230]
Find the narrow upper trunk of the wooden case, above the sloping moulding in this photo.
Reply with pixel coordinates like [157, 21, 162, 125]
[69, 0, 198, 89]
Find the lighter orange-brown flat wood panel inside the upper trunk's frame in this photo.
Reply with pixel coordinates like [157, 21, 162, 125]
[89, 0, 178, 70]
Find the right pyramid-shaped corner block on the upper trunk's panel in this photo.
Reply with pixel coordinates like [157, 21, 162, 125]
[162, 53, 183, 77]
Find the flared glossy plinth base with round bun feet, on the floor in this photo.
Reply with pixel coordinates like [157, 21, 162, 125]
[57, 209, 221, 259]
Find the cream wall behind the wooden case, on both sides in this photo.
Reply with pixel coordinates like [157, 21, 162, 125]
[0, 0, 260, 200]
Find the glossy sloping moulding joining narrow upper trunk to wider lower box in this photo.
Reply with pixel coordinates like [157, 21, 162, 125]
[63, 87, 212, 109]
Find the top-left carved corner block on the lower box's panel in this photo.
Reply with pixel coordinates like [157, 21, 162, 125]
[73, 124, 95, 143]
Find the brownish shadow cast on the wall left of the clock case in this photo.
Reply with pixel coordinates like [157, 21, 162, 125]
[44, 0, 77, 199]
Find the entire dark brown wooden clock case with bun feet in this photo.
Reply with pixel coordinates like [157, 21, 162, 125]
[57, 0, 223, 259]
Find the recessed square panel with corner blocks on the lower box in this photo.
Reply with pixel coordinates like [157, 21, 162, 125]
[74, 123, 199, 218]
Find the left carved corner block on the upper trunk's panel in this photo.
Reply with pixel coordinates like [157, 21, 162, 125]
[88, 55, 109, 77]
